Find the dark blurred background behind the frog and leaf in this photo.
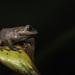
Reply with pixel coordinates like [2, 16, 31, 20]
[0, 0, 75, 75]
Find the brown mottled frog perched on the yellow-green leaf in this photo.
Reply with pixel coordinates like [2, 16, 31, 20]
[0, 25, 37, 51]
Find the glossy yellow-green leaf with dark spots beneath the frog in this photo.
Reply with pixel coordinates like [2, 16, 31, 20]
[0, 46, 40, 75]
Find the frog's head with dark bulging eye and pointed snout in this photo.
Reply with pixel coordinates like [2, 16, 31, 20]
[18, 25, 38, 36]
